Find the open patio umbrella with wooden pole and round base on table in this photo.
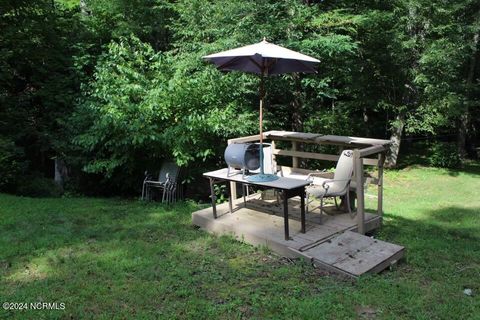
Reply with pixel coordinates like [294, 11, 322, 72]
[203, 38, 320, 181]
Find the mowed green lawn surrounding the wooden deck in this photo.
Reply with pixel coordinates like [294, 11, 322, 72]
[0, 164, 480, 319]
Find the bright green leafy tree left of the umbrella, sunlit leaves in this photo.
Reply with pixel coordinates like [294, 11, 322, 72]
[75, 36, 251, 180]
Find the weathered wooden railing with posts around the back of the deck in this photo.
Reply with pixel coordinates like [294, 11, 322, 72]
[228, 131, 391, 234]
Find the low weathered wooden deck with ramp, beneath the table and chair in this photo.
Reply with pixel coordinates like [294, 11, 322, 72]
[192, 194, 404, 277]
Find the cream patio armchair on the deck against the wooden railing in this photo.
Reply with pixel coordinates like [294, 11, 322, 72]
[305, 150, 353, 214]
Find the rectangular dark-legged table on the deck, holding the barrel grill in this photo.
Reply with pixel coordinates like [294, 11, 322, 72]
[203, 168, 310, 240]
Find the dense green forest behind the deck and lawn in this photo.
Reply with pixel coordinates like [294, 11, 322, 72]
[0, 0, 480, 197]
